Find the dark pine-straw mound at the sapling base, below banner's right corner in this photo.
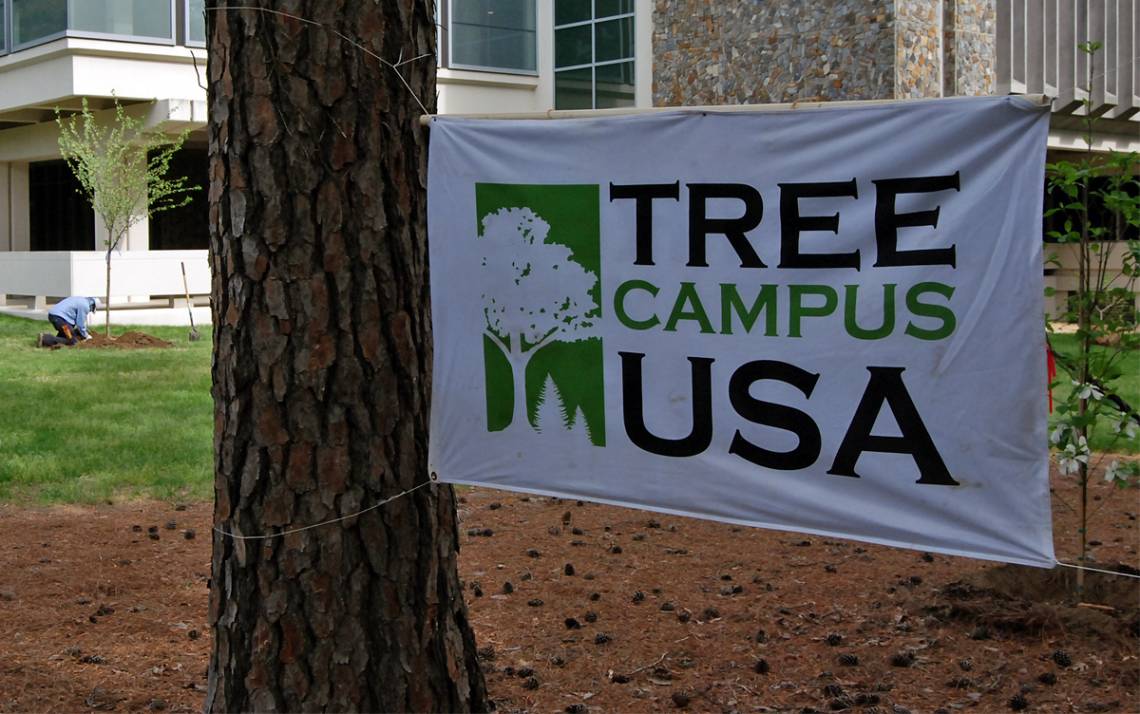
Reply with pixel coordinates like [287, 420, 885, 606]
[921, 565, 1140, 648]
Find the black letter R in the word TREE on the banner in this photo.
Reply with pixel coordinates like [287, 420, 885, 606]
[687, 184, 765, 268]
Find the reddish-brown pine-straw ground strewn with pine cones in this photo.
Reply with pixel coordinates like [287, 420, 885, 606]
[0, 467, 1140, 713]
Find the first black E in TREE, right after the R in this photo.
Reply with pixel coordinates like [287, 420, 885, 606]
[779, 179, 858, 270]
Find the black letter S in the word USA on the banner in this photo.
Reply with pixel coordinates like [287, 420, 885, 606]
[728, 359, 821, 471]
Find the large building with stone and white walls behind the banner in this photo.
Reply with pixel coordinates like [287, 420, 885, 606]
[0, 0, 1140, 321]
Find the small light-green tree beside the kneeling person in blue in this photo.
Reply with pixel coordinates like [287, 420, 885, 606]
[56, 97, 197, 336]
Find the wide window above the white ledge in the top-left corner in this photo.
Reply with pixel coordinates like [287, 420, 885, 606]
[8, 0, 174, 47]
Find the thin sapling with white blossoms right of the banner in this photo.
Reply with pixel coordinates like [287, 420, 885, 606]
[1045, 42, 1140, 595]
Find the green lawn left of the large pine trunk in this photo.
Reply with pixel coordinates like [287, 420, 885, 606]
[0, 315, 213, 504]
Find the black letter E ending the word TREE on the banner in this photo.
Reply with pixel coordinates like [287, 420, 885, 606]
[872, 171, 961, 268]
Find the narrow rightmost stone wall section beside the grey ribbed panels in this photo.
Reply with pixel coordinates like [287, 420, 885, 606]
[943, 0, 998, 97]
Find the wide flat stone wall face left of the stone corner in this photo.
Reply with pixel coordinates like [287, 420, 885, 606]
[653, 0, 896, 106]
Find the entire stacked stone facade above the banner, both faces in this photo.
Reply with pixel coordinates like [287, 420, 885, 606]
[653, 0, 995, 106]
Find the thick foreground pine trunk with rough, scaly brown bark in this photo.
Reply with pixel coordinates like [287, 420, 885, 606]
[206, 0, 486, 712]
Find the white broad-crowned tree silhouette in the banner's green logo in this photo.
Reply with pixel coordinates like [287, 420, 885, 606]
[480, 208, 597, 430]
